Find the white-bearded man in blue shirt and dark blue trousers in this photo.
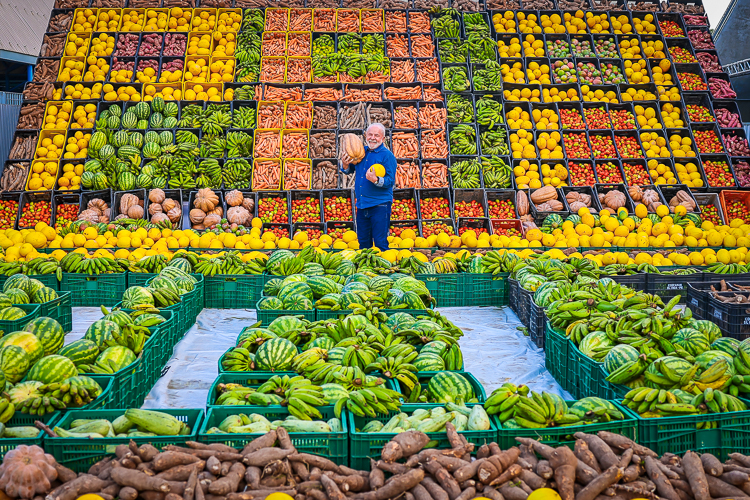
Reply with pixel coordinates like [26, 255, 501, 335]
[341, 123, 396, 250]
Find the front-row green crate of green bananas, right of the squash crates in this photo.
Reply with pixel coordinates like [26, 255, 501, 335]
[490, 401, 645, 450]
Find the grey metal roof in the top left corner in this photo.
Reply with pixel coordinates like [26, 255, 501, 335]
[0, 0, 54, 58]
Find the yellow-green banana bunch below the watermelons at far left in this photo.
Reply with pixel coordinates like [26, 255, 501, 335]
[15, 375, 102, 416]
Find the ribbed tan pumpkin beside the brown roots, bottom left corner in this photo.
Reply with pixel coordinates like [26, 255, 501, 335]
[0, 444, 57, 499]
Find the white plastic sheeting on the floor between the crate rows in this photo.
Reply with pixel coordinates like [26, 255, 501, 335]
[65, 307, 572, 408]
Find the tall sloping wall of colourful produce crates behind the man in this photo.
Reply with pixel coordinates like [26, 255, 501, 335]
[5, 0, 750, 244]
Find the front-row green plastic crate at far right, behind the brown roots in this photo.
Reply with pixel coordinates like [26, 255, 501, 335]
[636, 400, 750, 461]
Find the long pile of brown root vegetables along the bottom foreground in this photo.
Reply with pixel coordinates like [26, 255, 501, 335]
[17, 425, 750, 500]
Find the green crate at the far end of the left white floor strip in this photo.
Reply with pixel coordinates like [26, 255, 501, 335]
[204, 274, 264, 309]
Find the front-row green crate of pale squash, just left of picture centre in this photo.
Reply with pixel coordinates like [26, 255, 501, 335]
[198, 406, 349, 465]
